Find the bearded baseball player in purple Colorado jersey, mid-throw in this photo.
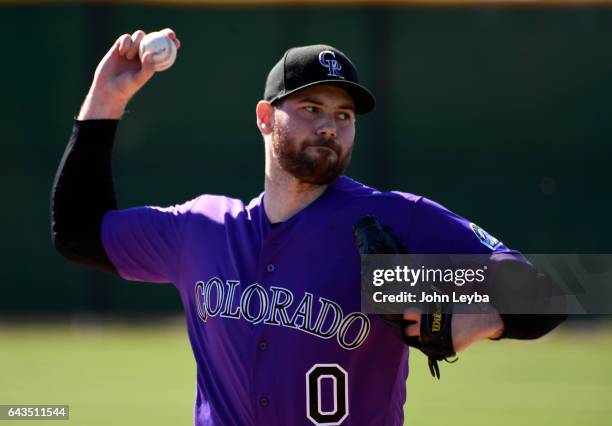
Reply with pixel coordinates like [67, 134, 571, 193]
[52, 29, 563, 426]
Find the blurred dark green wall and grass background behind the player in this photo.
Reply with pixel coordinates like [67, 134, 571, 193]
[0, 2, 612, 425]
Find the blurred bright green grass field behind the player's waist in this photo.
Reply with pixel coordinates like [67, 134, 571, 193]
[0, 322, 612, 426]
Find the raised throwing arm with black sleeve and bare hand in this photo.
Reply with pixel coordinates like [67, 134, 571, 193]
[51, 29, 180, 273]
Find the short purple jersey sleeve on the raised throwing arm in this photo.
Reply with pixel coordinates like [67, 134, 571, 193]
[101, 201, 193, 283]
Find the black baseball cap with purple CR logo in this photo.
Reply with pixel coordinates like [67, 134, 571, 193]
[264, 44, 376, 114]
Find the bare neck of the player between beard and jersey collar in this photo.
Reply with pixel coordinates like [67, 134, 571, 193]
[264, 164, 328, 223]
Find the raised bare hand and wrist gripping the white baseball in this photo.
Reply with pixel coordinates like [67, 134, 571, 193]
[77, 28, 181, 120]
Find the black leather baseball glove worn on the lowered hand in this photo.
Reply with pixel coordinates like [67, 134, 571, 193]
[353, 216, 457, 379]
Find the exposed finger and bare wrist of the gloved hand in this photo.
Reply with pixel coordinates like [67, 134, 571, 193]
[404, 304, 504, 352]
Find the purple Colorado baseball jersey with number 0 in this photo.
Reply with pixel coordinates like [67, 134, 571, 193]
[102, 176, 509, 426]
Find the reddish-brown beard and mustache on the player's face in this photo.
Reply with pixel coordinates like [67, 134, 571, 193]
[272, 122, 352, 185]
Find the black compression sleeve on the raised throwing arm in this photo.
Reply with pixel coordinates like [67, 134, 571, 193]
[51, 120, 119, 274]
